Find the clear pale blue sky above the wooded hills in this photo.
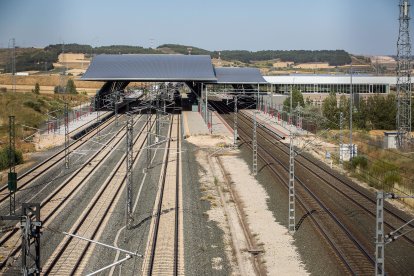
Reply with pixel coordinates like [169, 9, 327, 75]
[0, 0, 412, 55]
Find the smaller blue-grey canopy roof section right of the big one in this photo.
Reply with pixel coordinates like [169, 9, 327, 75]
[215, 67, 267, 84]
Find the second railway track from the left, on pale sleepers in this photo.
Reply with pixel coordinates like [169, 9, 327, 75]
[0, 113, 149, 271]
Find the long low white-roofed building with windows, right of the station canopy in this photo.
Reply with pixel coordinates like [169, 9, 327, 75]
[264, 75, 397, 94]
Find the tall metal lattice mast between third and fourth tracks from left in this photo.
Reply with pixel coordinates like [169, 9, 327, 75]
[125, 114, 134, 229]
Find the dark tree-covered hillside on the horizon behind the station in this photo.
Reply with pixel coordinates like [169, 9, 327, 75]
[0, 43, 351, 73]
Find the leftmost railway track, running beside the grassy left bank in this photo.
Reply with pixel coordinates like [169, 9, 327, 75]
[0, 112, 115, 208]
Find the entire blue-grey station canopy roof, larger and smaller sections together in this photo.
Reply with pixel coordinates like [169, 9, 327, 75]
[81, 54, 267, 84]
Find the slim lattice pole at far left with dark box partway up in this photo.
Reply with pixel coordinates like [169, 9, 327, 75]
[7, 116, 17, 215]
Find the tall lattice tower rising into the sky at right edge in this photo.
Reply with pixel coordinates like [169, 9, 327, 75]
[397, 0, 411, 148]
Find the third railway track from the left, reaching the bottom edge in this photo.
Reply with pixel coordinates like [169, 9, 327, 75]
[44, 113, 158, 275]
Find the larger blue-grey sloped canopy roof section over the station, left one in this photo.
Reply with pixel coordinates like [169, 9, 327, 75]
[82, 54, 217, 82]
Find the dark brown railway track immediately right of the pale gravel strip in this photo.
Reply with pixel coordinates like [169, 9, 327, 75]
[210, 100, 375, 275]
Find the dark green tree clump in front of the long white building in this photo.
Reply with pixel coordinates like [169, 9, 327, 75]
[322, 93, 397, 130]
